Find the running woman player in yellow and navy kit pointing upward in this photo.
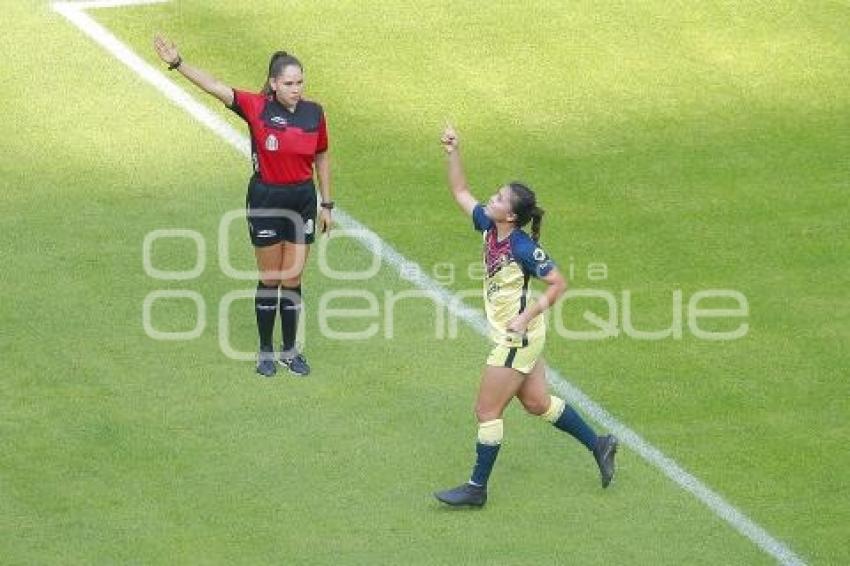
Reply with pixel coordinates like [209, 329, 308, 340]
[434, 126, 617, 507]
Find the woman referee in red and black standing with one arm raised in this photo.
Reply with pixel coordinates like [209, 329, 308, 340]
[154, 36, 334, 377]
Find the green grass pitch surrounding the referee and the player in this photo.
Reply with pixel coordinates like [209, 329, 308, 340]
[0, 0, 850, 564]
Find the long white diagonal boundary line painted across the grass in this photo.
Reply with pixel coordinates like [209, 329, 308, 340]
[52, 0, 805, 565]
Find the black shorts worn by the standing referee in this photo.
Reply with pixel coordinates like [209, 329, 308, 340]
[245, 175, 317, 248]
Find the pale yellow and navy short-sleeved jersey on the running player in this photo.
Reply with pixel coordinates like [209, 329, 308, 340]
[472, 204, 555, 347]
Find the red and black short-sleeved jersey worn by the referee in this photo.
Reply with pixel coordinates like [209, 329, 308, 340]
[230, 89, 328, 185]
